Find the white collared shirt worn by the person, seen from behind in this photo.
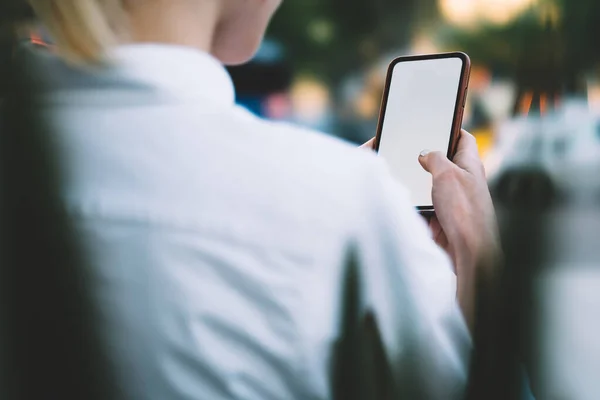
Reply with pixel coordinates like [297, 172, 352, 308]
[30, 45, 470, 400]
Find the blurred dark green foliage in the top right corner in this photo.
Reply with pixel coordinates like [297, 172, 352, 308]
[446, 0, 600, 77]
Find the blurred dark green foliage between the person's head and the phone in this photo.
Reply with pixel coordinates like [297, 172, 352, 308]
[269, 0, 422, 85]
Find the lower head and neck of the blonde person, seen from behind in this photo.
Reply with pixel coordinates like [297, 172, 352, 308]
[21, 0, 281, 64]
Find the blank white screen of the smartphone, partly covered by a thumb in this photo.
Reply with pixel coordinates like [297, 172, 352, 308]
[379, 57, 463, 207]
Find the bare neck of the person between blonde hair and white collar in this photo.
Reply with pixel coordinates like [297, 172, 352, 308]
[127, 0, 220, 53]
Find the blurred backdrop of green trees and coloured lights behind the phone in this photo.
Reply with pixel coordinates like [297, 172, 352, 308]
[232, 0, 600, 157]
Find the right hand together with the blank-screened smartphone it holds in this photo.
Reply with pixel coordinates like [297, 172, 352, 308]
[374, 53, 500, 328]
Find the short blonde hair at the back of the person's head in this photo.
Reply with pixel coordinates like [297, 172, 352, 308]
[29, 0, 125, 64]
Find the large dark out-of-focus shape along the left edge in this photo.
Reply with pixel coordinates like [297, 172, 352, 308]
[0, 27, 118, 400]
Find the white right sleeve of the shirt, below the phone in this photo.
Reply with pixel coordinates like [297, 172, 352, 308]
[358, 160, 472, 400]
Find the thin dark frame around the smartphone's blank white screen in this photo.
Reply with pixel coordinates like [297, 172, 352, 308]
[373, 51, 471, 216]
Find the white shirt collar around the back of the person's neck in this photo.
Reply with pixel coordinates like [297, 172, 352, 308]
[110, 44, 235, 105]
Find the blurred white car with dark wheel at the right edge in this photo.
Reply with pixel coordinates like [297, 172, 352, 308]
[485, 100, 600, 208]
